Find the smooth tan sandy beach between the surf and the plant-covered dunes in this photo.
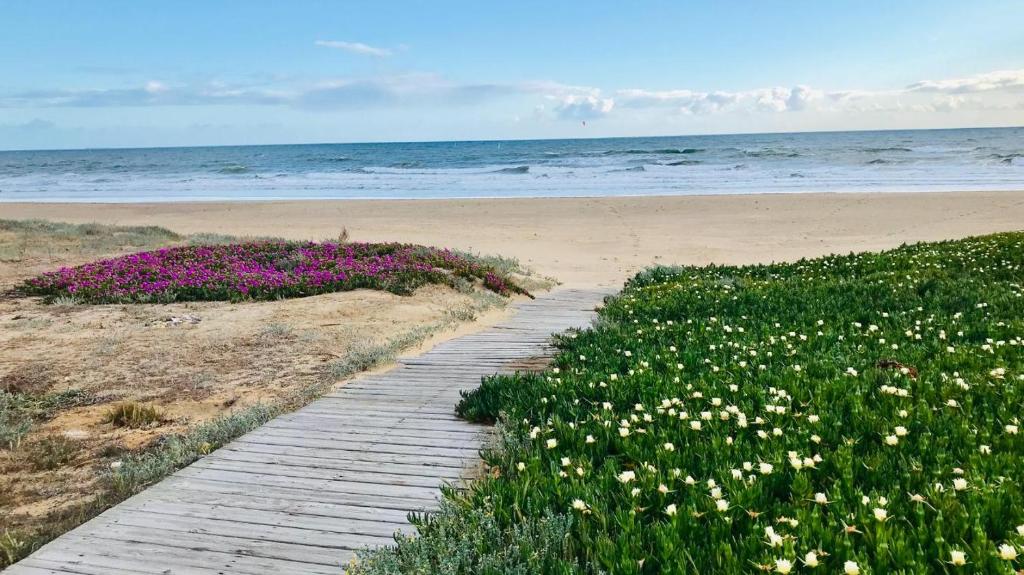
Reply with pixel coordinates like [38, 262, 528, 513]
[0, 191, 1024, 286]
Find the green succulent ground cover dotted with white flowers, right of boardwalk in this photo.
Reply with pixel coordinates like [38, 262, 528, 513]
[351, 233, 1024, 574]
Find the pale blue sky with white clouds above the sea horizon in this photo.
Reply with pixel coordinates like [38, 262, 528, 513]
[0, 0, 1024, 149]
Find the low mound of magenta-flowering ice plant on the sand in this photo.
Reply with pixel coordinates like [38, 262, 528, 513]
[23, 241, 528, 303]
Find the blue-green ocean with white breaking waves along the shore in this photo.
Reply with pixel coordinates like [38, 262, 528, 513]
[0, 128, 1024, 202]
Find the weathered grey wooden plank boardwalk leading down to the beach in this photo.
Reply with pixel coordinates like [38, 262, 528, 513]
[4, 290, 604, 575]
